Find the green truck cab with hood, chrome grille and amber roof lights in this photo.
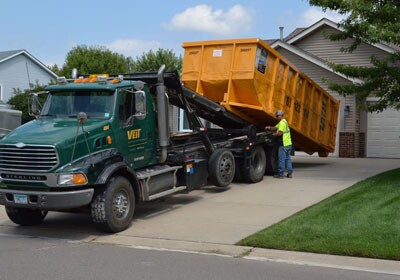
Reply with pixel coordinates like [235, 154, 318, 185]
[0, 76, 162, 231]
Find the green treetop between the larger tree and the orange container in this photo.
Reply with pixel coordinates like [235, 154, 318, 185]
[132, 48, 182, 73]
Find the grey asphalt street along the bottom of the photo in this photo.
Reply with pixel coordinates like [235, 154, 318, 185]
[0, 235, 398, 280]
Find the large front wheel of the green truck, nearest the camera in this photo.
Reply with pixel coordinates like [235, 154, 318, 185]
[91, 176, 135, 233]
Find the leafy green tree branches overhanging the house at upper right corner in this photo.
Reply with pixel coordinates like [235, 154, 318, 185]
[309, 0, 400, 112]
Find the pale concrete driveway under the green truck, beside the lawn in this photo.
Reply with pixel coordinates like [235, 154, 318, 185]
[0, 155, 400, 274]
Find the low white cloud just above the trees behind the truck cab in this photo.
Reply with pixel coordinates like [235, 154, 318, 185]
[105, 39, 161, 57]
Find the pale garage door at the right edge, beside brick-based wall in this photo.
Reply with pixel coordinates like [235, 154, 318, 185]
[367, 109, 400, 158]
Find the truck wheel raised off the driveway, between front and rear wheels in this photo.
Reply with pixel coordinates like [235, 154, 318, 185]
[208, 149, 235, 188]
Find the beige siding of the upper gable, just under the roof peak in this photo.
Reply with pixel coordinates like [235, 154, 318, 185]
[293, 26, 388, 66]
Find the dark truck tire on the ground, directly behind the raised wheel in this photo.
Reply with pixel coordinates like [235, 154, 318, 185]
[241, 145, 267, 183]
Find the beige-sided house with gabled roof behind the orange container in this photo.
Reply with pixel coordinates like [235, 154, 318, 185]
[266, 19, 400, 158]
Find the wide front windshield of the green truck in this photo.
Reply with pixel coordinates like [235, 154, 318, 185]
[40, 91, 114, 119]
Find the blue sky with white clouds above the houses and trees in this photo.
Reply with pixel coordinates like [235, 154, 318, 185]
[0, 0, 340, 66]
